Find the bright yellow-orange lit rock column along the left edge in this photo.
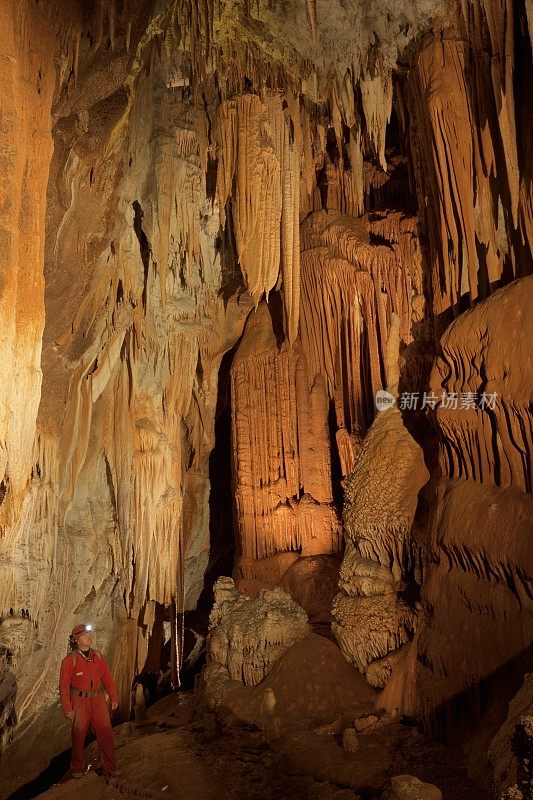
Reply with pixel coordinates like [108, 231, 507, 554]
[0, 2, 54, 556]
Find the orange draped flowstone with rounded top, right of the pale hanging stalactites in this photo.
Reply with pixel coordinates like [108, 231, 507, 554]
[301, 212, 419, 454]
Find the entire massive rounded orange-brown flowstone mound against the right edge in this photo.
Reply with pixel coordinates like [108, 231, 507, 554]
[382, 277, 533, 734]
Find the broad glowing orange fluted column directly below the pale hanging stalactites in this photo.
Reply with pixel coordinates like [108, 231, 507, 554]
[232, 304, 339, 584]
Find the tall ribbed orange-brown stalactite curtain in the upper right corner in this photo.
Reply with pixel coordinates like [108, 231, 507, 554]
[407, 0, 531, 313]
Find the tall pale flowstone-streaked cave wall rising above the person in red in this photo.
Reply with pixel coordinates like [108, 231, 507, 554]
[0, 4, 251, 744]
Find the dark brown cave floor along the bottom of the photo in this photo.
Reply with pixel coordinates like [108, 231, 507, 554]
[33, 695, 487, 800]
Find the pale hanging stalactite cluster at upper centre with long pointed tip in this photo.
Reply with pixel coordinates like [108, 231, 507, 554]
[215, 92, 303, 342]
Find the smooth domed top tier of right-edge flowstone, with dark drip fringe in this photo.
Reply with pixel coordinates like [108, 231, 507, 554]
[431, 276, 533, 494]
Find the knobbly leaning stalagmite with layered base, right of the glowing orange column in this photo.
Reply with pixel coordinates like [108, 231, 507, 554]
[332, 409, 429, 688]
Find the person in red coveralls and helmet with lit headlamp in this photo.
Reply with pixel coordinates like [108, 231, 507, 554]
[59, 625, 120, 778]
